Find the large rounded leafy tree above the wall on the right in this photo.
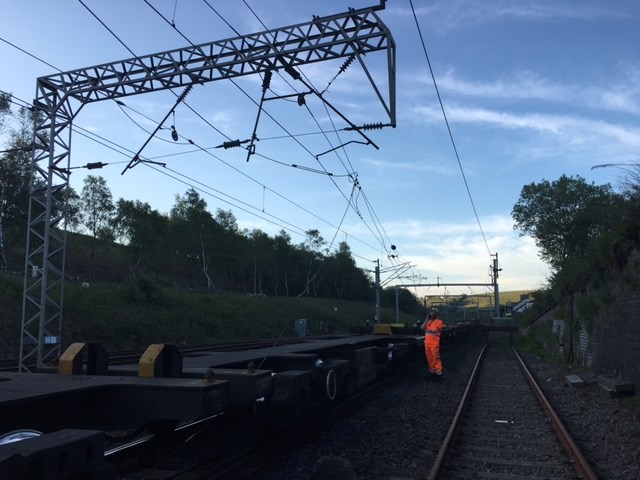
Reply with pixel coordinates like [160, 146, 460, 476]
[511, 175, 619, 270]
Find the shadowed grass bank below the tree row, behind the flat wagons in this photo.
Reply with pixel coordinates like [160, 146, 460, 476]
[0, 276, 416, 351]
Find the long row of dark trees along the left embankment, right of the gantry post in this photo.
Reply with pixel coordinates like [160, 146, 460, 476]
[28, 175, 374, 301]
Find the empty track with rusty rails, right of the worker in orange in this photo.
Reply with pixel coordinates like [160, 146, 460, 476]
[428, 347, 597, 480]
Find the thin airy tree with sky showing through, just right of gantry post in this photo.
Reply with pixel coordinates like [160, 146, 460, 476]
[80, 175, 115, 279]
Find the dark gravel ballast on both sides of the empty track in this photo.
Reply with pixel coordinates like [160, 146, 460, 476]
[258, 335, 640, 480]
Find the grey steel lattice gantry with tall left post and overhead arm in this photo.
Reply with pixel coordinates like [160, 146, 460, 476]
[20, 0, 396, 371]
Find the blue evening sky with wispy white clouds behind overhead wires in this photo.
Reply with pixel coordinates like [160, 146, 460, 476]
[0, 0, 640, 296]
